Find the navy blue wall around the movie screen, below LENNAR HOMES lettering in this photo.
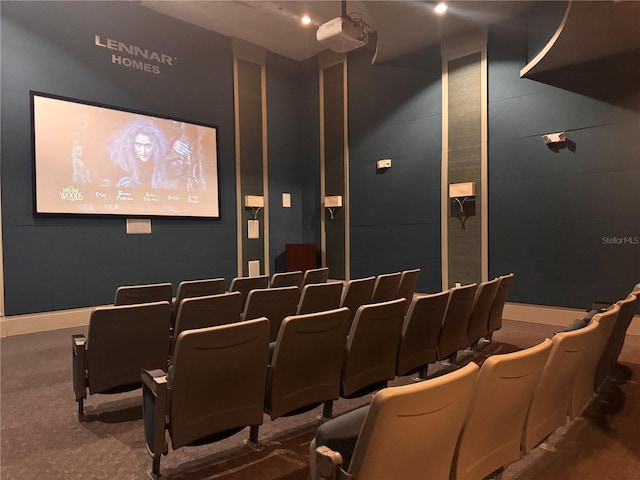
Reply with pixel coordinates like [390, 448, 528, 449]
[1, 2, 310, 315]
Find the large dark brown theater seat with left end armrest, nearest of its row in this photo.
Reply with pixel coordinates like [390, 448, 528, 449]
[142, 318, 269, 478]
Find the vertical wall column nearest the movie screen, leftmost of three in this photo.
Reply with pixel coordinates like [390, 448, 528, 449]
[233, 40, 269, 276]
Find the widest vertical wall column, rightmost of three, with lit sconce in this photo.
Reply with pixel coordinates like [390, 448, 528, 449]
[442, 28, 488, 289]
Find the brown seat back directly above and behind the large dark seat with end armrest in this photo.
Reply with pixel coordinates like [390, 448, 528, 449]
[173, 292, 242, 338]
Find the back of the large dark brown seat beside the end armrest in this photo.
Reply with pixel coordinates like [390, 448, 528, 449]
[168, 318, 269, 450]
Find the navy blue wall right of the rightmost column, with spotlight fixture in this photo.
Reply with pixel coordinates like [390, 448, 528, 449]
[488, 18, 640, 308]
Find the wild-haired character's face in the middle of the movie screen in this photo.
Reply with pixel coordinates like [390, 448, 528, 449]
[109, 118, 167, 188]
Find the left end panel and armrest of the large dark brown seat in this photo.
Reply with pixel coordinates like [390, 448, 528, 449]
[141, 370, 168, 476]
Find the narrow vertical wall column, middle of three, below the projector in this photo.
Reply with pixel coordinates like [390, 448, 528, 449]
[319, 52, 349, 280]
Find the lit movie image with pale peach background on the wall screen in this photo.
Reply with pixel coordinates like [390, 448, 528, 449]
[32, 93, 219, 217]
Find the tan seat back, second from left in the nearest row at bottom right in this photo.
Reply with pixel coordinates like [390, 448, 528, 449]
[452, 338, 551, 480]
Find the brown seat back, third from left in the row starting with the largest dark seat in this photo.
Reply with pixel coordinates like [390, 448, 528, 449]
[341, 298, 406, 397]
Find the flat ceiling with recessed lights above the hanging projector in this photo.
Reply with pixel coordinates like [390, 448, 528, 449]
[139, 0, 535, 61]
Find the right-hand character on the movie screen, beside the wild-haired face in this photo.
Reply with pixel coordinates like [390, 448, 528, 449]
[163, 122, 205, 191]
